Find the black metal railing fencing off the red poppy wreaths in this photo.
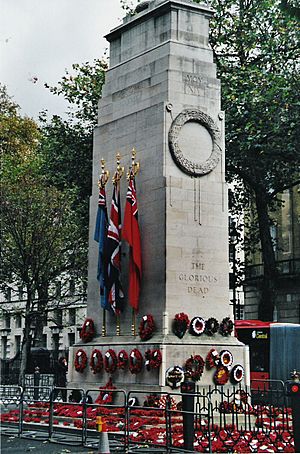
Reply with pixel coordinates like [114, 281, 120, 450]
[0, 381, 293, 453]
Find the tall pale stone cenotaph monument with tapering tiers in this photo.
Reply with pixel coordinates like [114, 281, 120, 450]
[68, 0, 249, 391]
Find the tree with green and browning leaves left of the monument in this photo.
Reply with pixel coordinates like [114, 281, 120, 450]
[0, 85, 86, 383]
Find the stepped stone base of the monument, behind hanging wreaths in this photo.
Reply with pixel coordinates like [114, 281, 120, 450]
[68, 334, 250, 394]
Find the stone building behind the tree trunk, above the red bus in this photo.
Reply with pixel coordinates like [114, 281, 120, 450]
[244, 185, 300, 323]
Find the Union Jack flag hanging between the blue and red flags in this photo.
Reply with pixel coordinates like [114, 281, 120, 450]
[105, 181, 124, 315]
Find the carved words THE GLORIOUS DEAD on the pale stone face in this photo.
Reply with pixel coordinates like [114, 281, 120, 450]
[177, 262, 218, 298]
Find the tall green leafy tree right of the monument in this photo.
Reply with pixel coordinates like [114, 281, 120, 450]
[206, 0, 300, 320]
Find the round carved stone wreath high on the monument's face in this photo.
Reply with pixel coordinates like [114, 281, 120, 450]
[169, 109, 221, 176]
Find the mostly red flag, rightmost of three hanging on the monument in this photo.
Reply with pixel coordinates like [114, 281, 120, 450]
[122, 173, 142, 312]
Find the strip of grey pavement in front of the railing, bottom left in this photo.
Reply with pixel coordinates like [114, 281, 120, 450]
[0, 434, 97, 454]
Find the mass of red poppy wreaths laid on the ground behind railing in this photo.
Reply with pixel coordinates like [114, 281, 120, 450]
[0, 394, 295, 453]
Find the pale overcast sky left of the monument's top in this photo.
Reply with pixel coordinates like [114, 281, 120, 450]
[0, 0, 135, 118]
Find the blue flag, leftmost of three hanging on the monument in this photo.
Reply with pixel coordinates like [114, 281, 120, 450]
[94, 186, 111, 310]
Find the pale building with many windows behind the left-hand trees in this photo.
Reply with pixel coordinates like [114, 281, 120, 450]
[0, 281, 86, 381]
